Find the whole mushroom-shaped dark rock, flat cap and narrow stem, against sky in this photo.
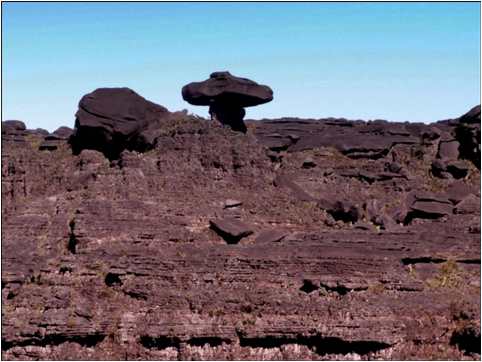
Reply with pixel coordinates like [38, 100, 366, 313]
[182, 72, 273, 132]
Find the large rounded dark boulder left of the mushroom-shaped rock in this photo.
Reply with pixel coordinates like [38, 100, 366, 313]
[71, 88, 169, 159]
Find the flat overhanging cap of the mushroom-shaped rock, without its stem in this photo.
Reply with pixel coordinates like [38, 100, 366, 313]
[182, 72, 273, 107]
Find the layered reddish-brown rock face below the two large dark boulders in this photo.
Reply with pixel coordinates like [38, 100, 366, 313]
[2, 104, 480, 360]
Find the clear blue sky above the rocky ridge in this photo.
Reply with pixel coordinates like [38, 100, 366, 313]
[2, 2, 480, 131]
